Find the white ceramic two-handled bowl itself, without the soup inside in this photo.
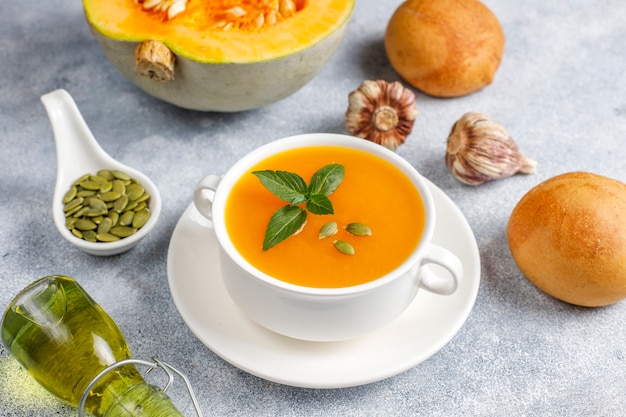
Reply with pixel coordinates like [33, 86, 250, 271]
[194, 133, 463, 341]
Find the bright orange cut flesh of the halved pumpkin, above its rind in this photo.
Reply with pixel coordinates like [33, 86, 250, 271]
[83, 0, 354, 63]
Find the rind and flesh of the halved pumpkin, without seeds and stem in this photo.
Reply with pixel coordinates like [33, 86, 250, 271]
[83, 0, 354, 112]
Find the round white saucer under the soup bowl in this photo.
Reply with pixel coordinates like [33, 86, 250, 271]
[167, 183, 480, 388]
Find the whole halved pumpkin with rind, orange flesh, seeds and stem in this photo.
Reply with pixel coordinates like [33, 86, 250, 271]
[83, 0, 355, 112]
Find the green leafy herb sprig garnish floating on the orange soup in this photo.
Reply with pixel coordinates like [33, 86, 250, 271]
[252, 164, 344, 250]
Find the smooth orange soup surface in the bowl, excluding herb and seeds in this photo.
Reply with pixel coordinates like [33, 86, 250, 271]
[225, 146, 424, 288]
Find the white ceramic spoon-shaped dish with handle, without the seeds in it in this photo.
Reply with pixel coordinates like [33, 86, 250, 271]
[41, 90, 161, 256]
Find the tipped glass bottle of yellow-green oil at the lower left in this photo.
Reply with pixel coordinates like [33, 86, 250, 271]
[1, 276, 182, 417]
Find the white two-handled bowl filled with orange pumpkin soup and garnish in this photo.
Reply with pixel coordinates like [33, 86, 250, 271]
[194, 133, 463, 341]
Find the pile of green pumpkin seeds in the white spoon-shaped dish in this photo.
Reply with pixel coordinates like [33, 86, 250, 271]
[63, 169, 150, 242]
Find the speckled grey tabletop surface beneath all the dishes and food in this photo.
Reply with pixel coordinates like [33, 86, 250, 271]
[0, 0, 626, 417]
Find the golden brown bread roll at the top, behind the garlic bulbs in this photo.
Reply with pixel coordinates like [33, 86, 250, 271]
[385, 0, 504, 97]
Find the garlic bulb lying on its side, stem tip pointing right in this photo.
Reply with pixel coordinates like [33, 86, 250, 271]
[446, 112, 537, 185]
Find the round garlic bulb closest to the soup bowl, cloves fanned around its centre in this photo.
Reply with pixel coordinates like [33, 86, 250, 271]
[346, 80, 418, 150]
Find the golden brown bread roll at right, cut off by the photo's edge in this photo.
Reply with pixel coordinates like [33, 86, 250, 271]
[507, 172, 626, 307]
